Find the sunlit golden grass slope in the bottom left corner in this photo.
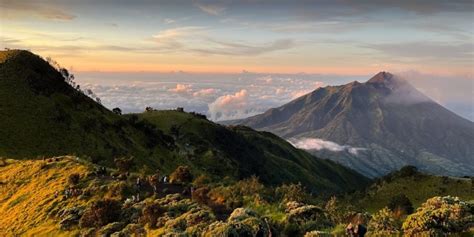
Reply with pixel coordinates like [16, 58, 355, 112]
[0, 157, 88, 236]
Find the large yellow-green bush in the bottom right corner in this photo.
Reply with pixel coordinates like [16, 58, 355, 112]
[403, 196, 474, 236]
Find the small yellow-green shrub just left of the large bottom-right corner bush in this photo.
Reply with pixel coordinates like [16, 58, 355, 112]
[368, 207, 402, 236]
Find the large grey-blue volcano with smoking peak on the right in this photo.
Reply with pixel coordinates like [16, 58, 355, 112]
[233, 72, 474, 177]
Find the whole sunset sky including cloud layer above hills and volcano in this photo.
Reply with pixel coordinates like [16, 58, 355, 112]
[0, 0, 474, 120]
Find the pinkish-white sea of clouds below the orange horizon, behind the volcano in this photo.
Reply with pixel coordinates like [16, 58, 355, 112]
[76, 71, 474, 121]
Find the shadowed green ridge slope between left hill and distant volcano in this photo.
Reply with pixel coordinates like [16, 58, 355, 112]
[133, 111, 368, 191]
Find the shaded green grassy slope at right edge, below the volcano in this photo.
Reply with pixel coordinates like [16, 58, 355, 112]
[355, 169, 474, 212]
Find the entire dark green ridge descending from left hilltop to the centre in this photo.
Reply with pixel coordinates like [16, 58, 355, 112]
[0, 50, 369, 192]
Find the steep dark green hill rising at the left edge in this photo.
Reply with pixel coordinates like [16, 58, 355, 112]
[0, 50, 172, 163]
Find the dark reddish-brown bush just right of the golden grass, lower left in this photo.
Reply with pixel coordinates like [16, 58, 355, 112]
[79, 199, 121, 228]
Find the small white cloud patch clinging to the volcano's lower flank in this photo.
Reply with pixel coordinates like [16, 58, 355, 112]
[290, 138, 366, 155]
